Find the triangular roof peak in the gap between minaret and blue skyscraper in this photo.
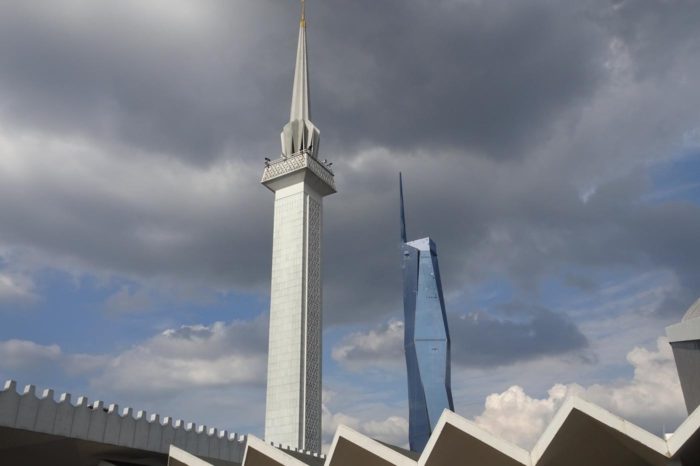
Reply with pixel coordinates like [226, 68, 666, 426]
[325, 426, 416, 466]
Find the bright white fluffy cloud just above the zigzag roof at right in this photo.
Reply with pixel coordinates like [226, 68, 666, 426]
[475, 338, 685, 448]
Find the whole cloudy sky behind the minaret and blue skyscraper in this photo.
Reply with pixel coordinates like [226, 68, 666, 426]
[0, 0, 700, 447]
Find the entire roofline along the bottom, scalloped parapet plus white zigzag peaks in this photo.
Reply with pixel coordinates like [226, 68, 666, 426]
[0, 381, 700, 466]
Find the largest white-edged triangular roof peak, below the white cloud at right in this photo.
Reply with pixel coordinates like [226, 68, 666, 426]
[531, 397, 671, 466]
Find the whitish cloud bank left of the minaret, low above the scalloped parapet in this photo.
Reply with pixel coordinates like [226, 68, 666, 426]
[0, 319, 267, 398]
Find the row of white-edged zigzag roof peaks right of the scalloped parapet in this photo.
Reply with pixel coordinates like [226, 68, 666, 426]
[237, 397, 700, 466]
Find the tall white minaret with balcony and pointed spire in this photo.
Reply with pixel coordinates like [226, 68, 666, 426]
[262, 1, 336, 452]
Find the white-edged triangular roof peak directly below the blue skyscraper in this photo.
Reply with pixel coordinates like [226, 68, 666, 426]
[418, 409, 531, 466]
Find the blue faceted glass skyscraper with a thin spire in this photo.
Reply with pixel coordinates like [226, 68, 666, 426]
[399, 174, 454, 452]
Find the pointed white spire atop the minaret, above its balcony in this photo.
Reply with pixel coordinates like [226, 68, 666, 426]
[281, 0, 320, 157]
